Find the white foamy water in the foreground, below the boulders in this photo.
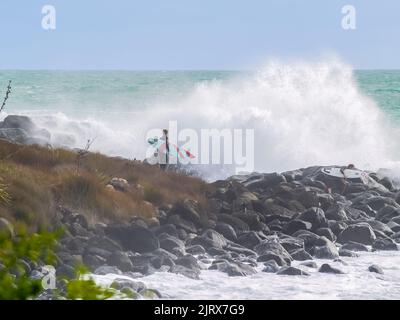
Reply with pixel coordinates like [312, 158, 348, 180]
[96, 251, 400, 300]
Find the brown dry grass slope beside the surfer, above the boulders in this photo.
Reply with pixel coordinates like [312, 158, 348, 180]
[0, 140, 209, 227]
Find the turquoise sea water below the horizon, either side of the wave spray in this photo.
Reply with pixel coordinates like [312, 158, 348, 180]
[0, 70, 400, 121]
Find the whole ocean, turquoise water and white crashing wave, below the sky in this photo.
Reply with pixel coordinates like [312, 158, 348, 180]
[0, 60, 400, 179]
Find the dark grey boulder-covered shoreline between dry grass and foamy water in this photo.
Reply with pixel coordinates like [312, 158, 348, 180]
[2, 115, 400, 297]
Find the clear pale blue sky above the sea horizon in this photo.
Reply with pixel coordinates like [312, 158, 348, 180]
[0, 0, 400, 70]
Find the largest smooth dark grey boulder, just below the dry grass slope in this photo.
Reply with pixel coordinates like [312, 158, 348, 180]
[105, 225, 160, 253]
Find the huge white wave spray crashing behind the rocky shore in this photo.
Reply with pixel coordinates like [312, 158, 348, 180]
[3, 59, 400, 179]
